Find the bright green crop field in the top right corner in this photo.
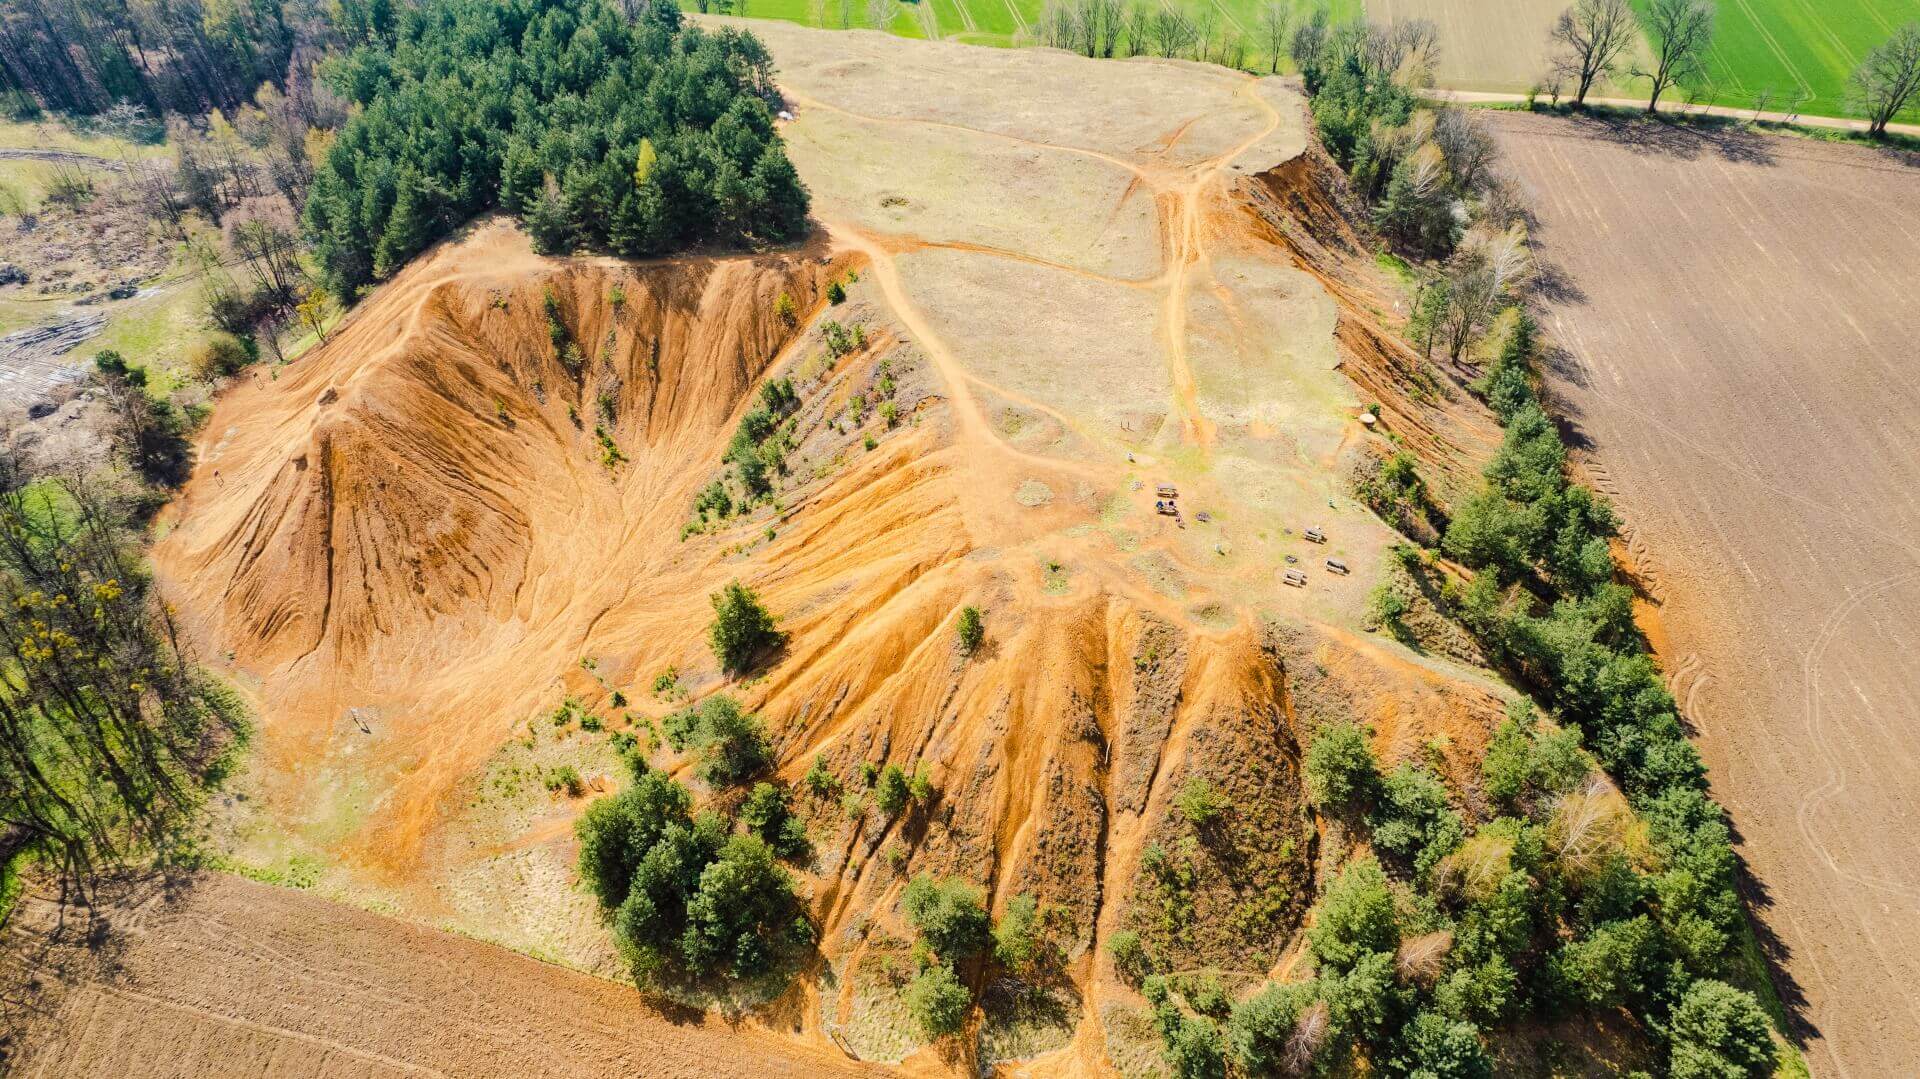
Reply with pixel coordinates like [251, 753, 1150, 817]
[1634, 0, 1920, 115]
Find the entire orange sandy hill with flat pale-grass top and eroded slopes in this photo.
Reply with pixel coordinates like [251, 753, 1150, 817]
[116, 23, 1507, 1073]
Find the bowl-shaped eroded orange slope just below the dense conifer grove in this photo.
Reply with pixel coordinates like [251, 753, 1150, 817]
[156, 223, 852, 864]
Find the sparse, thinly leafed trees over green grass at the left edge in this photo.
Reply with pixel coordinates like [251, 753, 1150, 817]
[0, 457, 248, 899]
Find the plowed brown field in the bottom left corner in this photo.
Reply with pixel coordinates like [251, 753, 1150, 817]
[0, 874, 872, 1079]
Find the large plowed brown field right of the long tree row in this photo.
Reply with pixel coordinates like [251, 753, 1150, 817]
[1500, 113, 1920, 1075]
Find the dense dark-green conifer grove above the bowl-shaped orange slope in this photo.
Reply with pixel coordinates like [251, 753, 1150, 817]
[303, 0, 808, 296]
